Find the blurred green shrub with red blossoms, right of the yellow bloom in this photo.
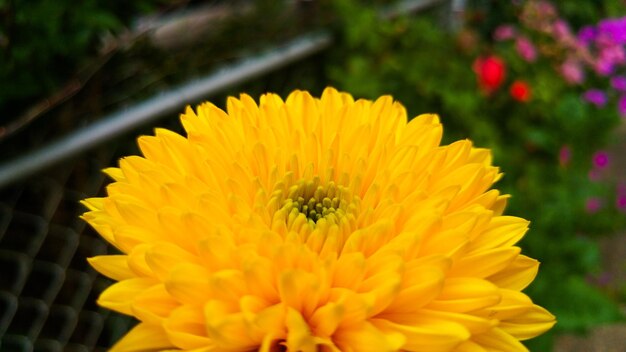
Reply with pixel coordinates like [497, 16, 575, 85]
[329, 0, 625, 351]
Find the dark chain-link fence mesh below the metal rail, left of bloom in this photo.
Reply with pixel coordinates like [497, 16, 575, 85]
[0, 146, 133, 352]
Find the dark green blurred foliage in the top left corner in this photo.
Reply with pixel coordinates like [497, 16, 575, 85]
[0, 0, 167, 122]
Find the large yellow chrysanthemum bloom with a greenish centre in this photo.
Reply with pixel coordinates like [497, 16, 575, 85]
[84, 88, 554, 352]
